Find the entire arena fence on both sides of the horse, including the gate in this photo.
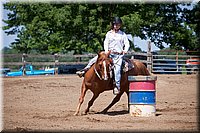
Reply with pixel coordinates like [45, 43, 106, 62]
[3, 42, 200, 74]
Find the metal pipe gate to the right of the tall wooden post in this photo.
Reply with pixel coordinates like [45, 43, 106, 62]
[151, 54, 200, 74]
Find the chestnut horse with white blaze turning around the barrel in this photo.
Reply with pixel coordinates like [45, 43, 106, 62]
[74, 51, 150, 115]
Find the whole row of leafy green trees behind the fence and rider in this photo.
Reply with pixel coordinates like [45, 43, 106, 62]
[3, 2, 200, 54]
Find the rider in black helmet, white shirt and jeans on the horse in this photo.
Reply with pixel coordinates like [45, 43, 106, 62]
[76, 17, 130, 95]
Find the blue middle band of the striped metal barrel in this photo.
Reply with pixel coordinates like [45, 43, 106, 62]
[129, 91, 156, 104]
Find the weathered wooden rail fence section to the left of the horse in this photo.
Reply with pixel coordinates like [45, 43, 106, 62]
[3, 54, 95, 66]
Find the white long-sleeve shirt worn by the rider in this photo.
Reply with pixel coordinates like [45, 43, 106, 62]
[104, 30, 130, 53]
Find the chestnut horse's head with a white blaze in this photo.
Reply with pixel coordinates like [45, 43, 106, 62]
[95, 52, 112, 80]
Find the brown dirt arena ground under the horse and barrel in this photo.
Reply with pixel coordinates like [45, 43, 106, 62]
[2, 75, 199, 132]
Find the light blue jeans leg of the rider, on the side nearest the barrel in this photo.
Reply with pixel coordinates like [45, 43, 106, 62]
[110, 54, 124, 89]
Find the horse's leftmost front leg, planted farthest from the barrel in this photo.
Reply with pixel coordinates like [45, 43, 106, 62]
[74, 81, 87, 115]
